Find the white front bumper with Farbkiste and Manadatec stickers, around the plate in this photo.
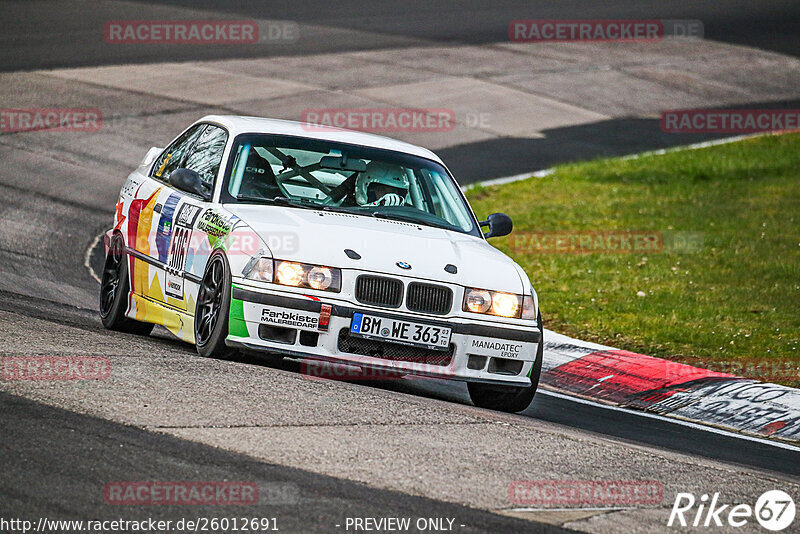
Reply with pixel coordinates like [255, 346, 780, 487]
[226, 283, 542, 386]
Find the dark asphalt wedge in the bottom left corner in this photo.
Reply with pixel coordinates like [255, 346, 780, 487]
[0, 394, 563, 532]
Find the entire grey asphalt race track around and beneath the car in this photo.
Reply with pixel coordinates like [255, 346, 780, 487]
[0, 0, 800, 532]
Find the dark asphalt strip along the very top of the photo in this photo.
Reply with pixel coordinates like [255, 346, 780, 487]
[0, 0, 800, 71]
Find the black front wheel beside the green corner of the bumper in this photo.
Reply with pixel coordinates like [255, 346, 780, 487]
[194, 252, 236, 360]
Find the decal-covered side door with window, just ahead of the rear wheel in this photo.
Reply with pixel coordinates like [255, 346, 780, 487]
[157, 124, 228, 314]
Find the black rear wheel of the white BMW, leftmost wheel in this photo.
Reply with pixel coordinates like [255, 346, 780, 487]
[100, 234, 155, 336]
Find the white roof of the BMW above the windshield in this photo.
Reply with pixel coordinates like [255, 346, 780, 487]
[197, 115, 444, 164]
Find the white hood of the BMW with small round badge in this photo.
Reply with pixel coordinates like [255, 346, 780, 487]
[225, 204, 523, 293]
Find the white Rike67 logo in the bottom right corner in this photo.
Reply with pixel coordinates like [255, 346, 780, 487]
[667, 490, 796, 532]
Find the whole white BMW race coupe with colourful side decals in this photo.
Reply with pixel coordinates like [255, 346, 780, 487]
[100, 116, 542, 412]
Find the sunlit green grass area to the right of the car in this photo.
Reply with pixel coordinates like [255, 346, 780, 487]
[467, 134, 800, 386]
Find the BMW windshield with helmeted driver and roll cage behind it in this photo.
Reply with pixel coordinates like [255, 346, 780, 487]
[223, 134, 480, 235]
